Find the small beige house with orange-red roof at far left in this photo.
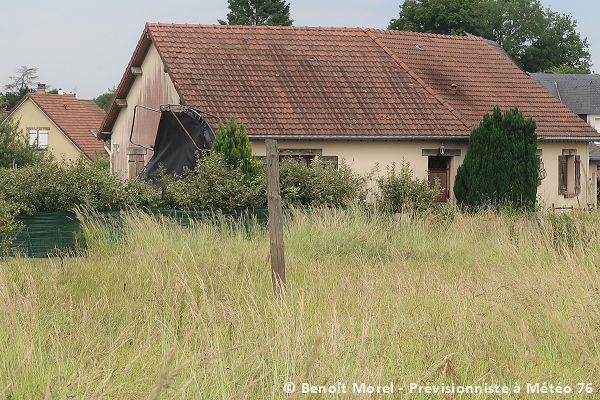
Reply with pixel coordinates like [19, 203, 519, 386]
[9, 92, 106, 160]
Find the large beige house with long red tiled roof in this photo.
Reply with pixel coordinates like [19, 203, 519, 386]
[100, 24, 600, 207]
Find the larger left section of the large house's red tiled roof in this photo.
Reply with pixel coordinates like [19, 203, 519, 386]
[148, 24, 470, 136]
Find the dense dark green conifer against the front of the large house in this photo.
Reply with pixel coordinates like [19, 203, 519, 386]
[454, 106, 538, 210]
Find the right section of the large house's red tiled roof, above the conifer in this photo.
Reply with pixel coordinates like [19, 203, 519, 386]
[369, 30, 597, 138]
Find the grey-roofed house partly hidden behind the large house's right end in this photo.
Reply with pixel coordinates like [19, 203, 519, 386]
[529, 73, 600, 203]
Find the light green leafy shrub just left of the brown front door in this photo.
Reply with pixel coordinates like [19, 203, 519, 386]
[376, 160, 442, 213]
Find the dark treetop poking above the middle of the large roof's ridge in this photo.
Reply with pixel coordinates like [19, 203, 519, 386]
[218, 0, 294, 26]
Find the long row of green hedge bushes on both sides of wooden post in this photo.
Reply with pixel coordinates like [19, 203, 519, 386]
[0, 153, 366, 214]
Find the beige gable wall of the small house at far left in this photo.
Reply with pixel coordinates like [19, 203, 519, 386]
[11, 99, 81, 160]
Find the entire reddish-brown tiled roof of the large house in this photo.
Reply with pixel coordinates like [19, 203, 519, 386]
[102, 23, 598, 138]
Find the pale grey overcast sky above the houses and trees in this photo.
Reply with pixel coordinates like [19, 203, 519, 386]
[0, 0, 600, 99]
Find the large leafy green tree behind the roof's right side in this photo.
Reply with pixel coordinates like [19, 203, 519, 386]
[389, 0, 591, 73]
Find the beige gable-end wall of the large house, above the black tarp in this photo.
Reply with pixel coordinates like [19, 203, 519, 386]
[111, 44, 179, 177]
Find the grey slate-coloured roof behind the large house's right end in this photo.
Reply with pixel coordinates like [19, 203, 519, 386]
[529, 73, 600, 114]
